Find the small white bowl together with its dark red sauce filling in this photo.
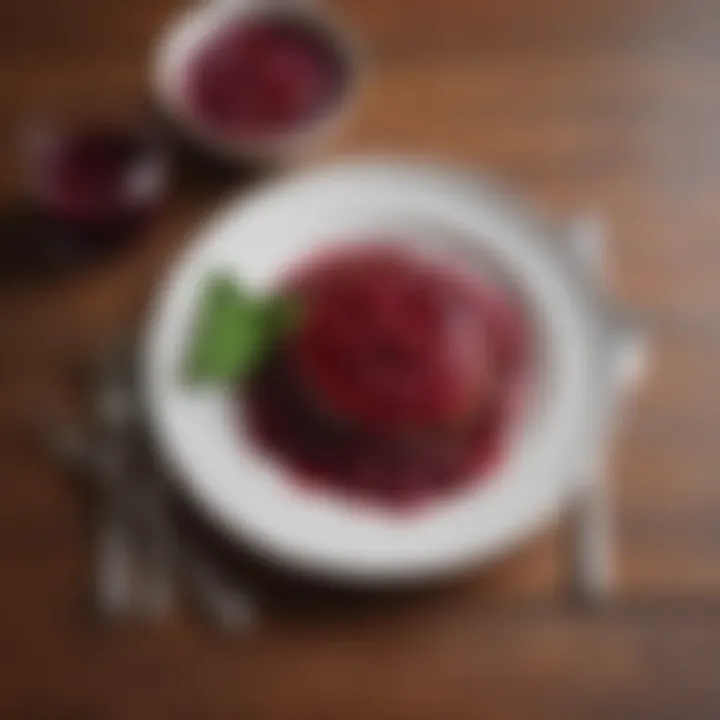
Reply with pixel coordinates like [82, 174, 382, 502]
[154, 0, 357, 160]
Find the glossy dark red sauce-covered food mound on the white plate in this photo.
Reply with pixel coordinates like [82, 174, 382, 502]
[247, 247, 527, 505]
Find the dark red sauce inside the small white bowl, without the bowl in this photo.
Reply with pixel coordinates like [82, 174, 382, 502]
[188, 16, 344, 137]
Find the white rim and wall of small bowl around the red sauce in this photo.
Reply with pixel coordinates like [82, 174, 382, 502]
[151, 0, 361, 163]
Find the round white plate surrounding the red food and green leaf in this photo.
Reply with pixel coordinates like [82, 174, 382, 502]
[141, 160, 611, 582]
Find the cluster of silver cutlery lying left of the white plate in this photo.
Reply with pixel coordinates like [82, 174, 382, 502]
[45, 350, 257, 632]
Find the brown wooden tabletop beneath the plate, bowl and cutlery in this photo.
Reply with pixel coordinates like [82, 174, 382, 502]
[0, 0, 720, 720]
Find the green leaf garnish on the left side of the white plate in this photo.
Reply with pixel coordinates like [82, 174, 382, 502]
[186, 276, 299, 383]
